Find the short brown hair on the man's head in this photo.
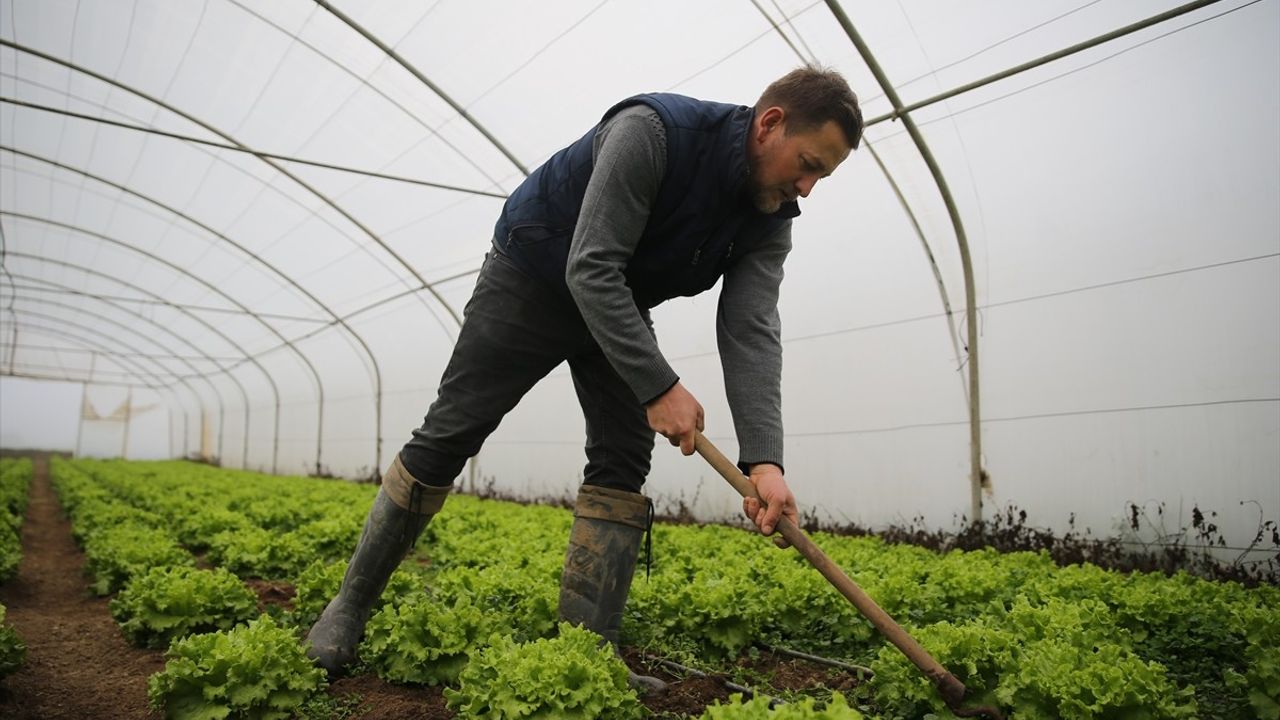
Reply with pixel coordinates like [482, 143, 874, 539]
[755, 65, 863, 150]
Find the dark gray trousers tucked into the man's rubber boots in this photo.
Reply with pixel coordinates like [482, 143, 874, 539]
[399, 250, 654, 492]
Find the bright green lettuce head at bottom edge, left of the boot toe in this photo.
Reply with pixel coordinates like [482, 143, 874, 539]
[147, 615, 326, 720]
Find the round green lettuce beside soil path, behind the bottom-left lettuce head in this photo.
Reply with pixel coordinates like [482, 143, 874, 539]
[110, 566, 257, 648]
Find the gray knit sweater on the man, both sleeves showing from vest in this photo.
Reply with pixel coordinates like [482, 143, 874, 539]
[566, 105, 791, 466]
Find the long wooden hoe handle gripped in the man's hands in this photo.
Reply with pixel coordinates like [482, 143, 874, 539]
[694, 433, 1002, 720]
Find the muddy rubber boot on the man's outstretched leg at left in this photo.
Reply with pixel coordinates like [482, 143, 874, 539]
[306, 456, 451, 678]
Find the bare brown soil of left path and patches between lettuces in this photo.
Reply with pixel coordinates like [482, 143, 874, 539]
[0, 455, 838, 720]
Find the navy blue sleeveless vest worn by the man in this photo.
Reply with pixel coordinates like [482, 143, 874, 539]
[494, 94, 800, 307]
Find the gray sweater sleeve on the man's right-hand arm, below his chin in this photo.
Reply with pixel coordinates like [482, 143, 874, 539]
[716, 223, 791, 473]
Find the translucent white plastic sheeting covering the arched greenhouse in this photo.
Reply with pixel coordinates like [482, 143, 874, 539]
[0, 0, 1280, 556]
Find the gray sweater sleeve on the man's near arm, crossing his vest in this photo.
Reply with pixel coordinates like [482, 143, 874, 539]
[564, 106, 680, 402]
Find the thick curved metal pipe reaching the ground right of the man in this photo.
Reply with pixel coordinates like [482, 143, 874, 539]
[827, 0, 986, 524]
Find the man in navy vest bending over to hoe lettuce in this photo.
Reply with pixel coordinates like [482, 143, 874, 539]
[307, 68, 863, 688]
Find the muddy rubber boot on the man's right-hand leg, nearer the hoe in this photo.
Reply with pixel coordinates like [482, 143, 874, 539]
[559, 486, 667, 692]
